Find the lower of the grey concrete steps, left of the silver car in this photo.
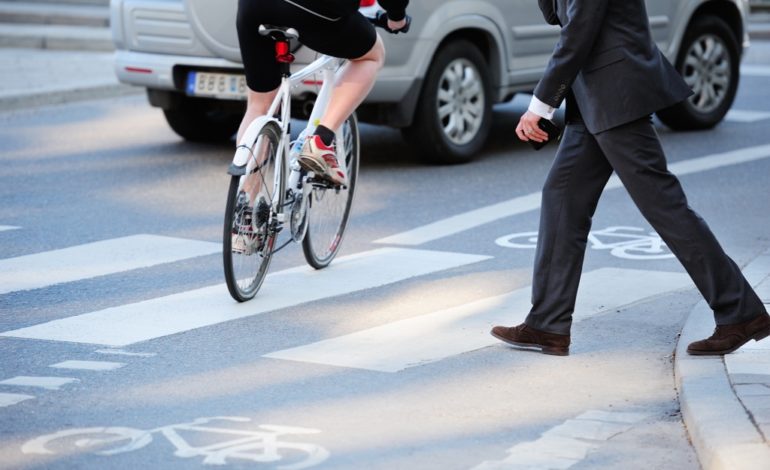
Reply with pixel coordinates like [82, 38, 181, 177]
[0, 24, 115, 51]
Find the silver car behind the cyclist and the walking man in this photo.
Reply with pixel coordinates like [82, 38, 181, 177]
[111, 0, 748, 163]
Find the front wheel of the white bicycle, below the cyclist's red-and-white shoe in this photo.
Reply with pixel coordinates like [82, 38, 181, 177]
[302, 113, 360, 269]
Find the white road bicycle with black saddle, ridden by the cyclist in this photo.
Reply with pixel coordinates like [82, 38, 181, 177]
[223, 25, 360, 302]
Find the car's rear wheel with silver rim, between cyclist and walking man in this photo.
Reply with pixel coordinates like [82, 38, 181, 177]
[403, 40, 492, 164]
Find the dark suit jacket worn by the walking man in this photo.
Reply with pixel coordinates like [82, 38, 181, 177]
[535, 0, 692, 134]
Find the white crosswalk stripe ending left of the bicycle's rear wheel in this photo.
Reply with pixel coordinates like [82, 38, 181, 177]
[0, 235, 222, 294]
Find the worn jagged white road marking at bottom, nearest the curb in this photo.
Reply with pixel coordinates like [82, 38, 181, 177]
[473, 411, 649, 470]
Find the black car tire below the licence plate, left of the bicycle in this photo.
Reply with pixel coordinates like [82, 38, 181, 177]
[163, 98, 243, 143]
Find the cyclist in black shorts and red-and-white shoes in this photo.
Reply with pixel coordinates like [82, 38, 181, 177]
[237, 0, 409, 185]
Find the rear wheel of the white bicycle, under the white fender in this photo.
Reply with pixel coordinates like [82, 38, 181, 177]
[222, 124, 284, 302]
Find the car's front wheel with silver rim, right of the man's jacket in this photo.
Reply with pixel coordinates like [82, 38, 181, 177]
[658, 16, 741, 130]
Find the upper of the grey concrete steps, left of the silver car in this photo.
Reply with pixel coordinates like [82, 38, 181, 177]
[0, 0, 110, 27]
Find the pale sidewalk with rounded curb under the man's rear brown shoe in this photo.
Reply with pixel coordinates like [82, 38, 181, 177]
[674, 250, 770, 470]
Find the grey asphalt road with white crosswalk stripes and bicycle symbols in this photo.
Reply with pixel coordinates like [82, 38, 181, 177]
[0, 43, 770, 469]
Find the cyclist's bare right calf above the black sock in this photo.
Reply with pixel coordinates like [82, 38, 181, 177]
[320, 34, 385, 130]
